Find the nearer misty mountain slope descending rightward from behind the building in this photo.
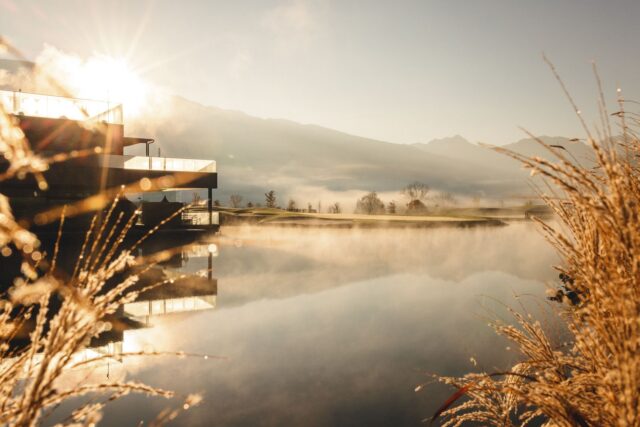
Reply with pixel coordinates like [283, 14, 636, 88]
[138, 98, 528, 198]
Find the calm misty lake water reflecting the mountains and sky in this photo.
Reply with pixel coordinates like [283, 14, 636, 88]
[52, 223, 557, 426]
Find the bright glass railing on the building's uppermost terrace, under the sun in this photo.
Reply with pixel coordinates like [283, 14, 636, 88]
[0, 90, 123, 124]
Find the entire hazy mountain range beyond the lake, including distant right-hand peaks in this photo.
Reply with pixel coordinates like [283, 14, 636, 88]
[0, 59, 590, 204]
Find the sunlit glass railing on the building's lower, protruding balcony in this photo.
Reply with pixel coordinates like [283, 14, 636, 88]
[104, 154, 216, 173]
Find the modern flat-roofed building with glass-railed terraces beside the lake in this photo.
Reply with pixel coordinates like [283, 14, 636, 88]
[0, 90, 218, 229]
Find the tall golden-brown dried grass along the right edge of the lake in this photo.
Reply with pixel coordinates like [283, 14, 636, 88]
[432, 64, 640, 426]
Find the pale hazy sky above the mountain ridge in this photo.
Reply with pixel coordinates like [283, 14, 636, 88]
[0, 0, 640, 144]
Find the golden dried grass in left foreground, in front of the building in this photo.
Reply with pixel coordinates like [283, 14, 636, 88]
[0, 38, 201, 426]
